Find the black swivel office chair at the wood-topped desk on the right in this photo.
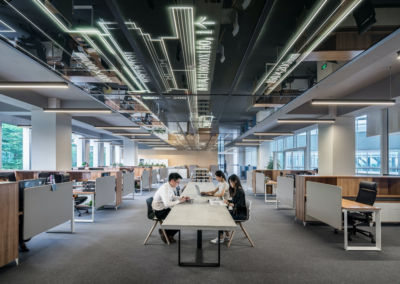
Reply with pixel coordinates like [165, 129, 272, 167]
[347, 181, 378, 244]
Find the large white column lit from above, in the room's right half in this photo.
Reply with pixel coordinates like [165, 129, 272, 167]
[318, 117, 356, 175]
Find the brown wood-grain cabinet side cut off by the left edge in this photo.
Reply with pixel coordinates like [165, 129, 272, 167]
[0, 182, 19, 267]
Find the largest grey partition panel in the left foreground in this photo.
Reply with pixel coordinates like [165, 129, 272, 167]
[23, 182, 73, 240]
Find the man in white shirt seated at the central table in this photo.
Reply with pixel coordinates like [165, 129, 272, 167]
[151, 173, 190, 243]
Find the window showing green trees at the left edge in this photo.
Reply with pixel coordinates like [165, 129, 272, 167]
[1, 123, 23, 170]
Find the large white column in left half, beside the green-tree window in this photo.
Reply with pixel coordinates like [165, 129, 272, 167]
[31, 110, 72, 171]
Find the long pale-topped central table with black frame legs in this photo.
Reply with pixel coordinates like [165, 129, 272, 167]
[162, 182, 236, 267]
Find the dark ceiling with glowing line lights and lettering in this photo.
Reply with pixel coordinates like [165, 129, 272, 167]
[0, 0, 400, 150]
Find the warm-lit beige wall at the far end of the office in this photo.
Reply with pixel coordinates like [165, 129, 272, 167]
[139, 150, 218, 169]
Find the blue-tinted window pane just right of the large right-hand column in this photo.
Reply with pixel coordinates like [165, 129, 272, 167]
[355, 112, 382, 174]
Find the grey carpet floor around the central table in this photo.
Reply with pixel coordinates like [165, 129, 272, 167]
[0, 182, 400, 284]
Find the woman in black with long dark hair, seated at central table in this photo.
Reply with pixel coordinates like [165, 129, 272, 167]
[211, 175, 247, 244]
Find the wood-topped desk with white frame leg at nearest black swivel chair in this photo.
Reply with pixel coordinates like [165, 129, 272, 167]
[342, 199, 382, 251]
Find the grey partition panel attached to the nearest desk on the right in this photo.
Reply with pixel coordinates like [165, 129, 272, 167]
[306, 181, 342, 230]
